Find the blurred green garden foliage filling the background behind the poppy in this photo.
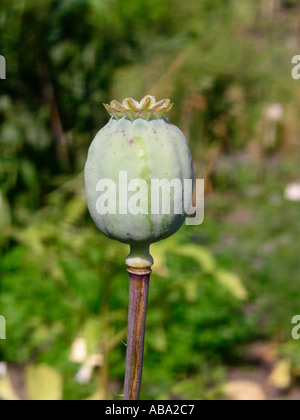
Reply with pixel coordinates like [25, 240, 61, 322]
[0, 0, 300, 399]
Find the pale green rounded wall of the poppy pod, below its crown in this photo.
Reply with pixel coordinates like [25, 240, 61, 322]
[85, 97, 193, 268]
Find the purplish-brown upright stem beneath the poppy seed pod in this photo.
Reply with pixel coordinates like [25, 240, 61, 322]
[123, 267, 151, 400]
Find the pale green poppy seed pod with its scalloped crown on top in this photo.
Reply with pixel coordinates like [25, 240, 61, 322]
[85, 96, 193, 268]
